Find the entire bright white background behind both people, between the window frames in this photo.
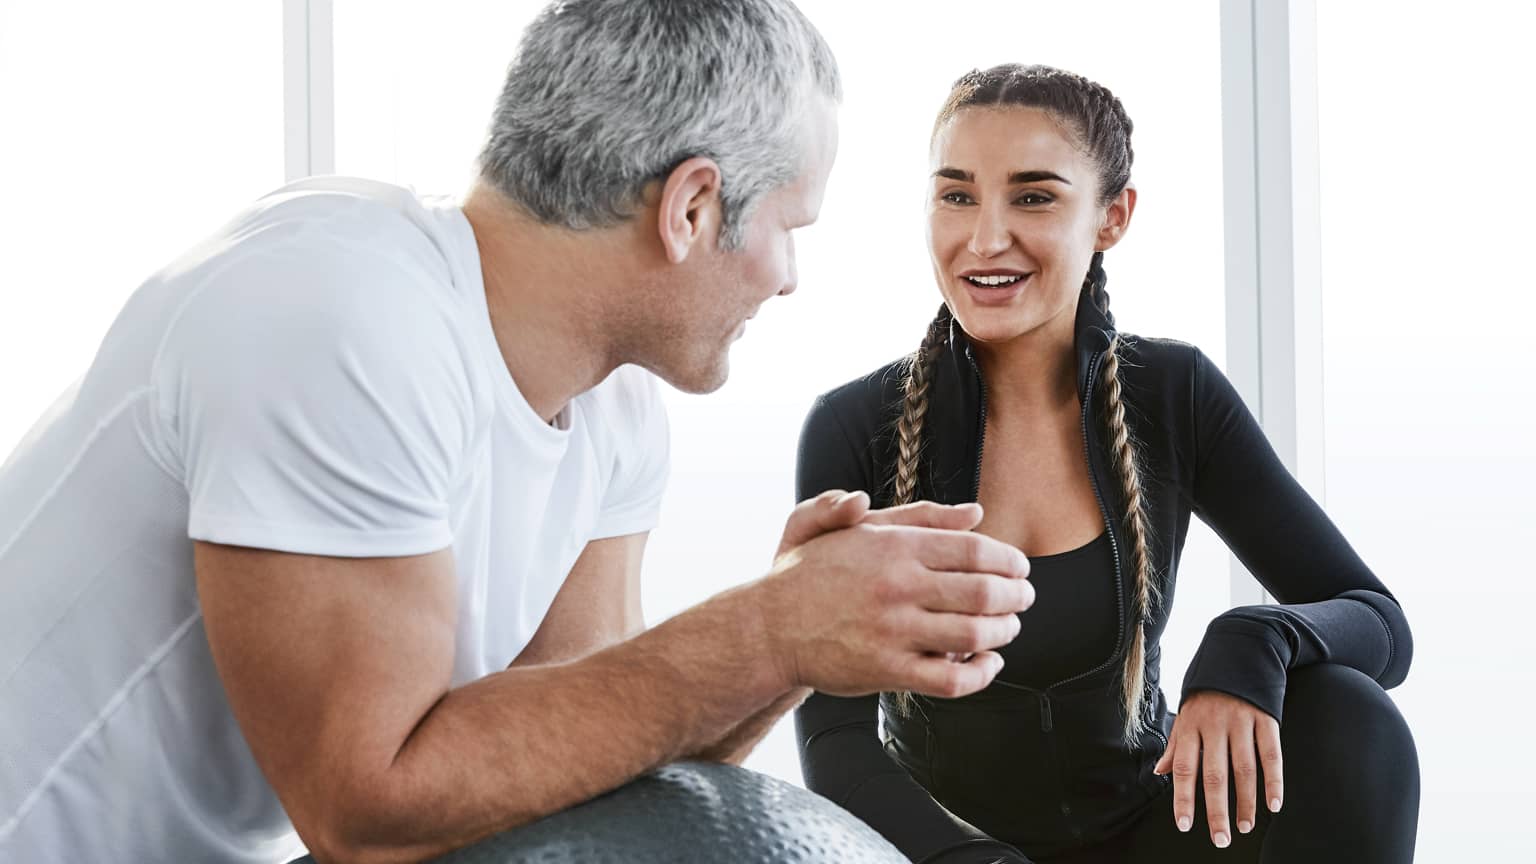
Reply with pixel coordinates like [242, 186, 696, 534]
[0, 0, 1536, 861]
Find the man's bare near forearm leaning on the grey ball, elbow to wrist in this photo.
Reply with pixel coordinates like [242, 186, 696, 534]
[335, 578, 791, 861]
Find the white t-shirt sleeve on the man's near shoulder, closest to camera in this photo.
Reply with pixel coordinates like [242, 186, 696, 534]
[155, 243, 473, 557]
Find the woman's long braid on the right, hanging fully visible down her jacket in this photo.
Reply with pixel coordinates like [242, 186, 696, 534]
[1089, 272, 1160, 744]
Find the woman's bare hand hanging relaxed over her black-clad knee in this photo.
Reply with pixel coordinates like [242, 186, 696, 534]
[1152, 690, 1284, 847]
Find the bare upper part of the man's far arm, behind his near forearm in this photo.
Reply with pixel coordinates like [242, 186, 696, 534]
[511, 532, 650, 666]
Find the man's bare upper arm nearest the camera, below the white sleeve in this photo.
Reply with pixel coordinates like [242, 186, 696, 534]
[194, 543, 455, 833]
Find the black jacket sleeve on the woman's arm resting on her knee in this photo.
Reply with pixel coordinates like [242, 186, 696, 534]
[1184, 349, 1413, 719]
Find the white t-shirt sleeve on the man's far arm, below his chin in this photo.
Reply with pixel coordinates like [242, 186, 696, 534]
[593, 366, 671, 540]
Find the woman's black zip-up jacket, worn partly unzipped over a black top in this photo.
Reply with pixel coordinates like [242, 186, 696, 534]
[796, 292, 1413, 861]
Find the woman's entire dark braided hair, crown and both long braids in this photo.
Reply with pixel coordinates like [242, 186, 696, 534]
[891, 63, 1158, 743]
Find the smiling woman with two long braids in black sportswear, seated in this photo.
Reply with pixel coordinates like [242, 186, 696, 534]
[796, 65, 1419, 864]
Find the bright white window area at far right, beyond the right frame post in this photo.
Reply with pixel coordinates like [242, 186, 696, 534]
[1318, 2, 1536, 862]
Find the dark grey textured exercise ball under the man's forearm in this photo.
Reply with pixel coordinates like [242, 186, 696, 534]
[295, 763, 906, 864]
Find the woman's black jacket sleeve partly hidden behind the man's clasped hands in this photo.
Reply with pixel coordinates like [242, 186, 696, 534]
[794, 397, 1026, 864]
